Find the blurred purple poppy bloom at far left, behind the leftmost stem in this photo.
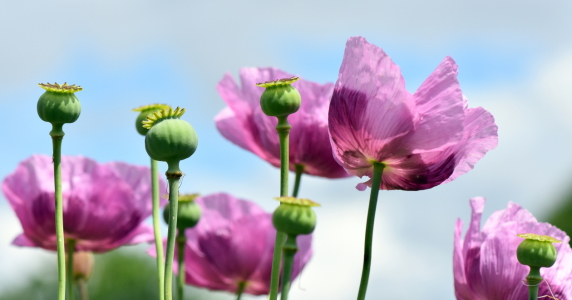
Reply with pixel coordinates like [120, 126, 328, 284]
[2, 155, 165, 252]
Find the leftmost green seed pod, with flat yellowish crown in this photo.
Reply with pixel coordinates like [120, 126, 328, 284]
[37, 83, 82, 124]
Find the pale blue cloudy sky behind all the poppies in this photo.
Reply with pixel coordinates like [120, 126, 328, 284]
[0, 0, 572, 300]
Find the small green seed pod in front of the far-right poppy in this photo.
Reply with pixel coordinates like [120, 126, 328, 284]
[516, 233, 562, 268]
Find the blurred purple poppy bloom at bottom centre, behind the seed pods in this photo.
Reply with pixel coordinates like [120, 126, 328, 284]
[173, 193, 312, 295]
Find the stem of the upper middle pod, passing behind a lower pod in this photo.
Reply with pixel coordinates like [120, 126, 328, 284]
[268, 116, 292, 300]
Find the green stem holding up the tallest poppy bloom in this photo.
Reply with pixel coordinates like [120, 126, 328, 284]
[358, 162, 385, 300]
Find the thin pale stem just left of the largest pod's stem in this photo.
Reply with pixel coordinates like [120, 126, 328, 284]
[151, 159, 165, 300]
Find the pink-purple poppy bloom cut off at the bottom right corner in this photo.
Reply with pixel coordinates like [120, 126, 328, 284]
[453, 197, 572, 300]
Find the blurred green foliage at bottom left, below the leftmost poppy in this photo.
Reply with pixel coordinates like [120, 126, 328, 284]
[0, 245, 235, 300]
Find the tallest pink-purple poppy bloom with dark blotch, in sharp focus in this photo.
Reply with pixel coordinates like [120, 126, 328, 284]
[328, 37, 497, 190]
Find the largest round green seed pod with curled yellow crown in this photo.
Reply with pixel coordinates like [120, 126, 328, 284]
[143, 107, 198, 173]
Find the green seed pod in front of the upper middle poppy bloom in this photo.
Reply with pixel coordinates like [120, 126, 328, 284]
[256, 77, 301, 117]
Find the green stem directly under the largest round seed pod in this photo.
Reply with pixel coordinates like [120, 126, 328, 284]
[165, 168, 182, 300]
